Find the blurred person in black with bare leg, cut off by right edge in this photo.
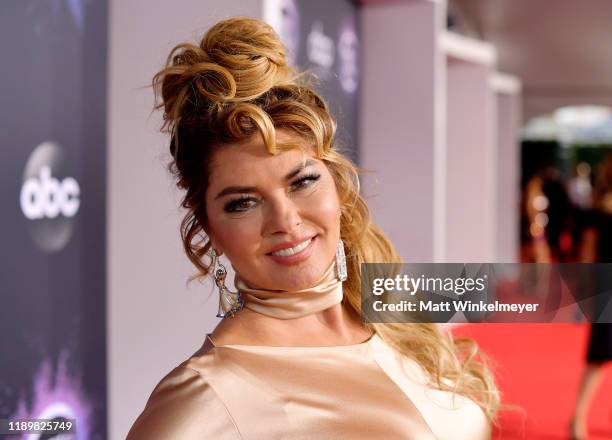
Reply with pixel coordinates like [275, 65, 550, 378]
[570, 153, 612, 439]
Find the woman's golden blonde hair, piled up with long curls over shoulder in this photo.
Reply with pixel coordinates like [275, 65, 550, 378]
[153, 17, 499, 420]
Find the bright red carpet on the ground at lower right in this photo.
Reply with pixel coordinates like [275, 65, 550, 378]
[453, 324, 612, 440]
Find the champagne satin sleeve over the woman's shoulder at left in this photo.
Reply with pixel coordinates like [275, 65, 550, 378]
[127, 353, 240, 440]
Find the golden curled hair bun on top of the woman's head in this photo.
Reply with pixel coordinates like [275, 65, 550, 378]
[153, 17, 292, 121]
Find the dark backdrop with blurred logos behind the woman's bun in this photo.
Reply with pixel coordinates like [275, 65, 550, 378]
[263, 0, 361, 163]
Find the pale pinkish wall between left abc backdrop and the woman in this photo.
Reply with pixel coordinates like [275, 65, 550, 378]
[107, 0, 262, 439]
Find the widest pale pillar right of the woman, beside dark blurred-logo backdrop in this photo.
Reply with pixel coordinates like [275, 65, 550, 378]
[360, 1, 445, 262]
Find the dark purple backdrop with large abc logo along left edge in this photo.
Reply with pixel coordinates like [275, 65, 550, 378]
[0, 0, 107, 439]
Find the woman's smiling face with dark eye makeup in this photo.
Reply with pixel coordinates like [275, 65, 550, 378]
[206, 132, 340, 290]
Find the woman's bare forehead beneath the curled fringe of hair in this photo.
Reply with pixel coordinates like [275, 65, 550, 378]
[209, 136, 314, 187]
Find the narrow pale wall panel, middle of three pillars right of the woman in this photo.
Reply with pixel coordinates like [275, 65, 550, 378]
[446, 57, 498, 263]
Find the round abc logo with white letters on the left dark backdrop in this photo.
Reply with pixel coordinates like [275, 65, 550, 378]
[19, 142, 81, 252]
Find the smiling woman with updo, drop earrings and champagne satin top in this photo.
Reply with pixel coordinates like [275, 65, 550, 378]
[128, 17, 498, 440]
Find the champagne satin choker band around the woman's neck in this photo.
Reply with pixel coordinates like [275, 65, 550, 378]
[234, 261, 343, 319]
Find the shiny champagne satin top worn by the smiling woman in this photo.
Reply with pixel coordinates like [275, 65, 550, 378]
[127, 335, 490, 440]
